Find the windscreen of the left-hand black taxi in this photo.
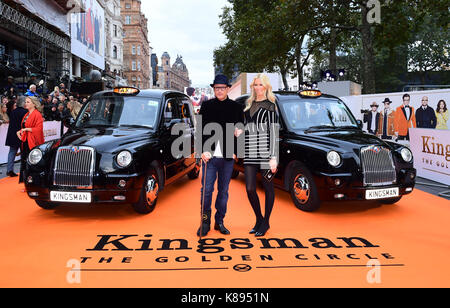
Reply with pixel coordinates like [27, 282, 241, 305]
[76, 96, 160, 128]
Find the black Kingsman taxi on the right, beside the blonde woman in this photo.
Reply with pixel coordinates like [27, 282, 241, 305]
[233, 90, 416, 212]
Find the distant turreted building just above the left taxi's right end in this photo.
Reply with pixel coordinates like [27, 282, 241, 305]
[156, 52, 191, 92]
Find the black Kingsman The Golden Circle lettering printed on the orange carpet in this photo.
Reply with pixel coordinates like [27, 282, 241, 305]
[74, 234, 403, 272]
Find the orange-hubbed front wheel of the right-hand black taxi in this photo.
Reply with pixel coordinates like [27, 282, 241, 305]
[289, 164, 320, 212]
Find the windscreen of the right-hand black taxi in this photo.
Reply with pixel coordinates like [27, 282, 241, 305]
[281, 100, 358, 130]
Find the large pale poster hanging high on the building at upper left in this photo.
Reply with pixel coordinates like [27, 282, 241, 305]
[70, 0, 105, 70]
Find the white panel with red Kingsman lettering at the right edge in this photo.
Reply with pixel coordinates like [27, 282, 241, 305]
[409, 128, 450, 185]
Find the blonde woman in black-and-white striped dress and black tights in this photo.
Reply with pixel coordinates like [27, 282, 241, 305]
[244, 74, 279, 236]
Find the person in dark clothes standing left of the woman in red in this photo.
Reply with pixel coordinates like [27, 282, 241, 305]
[5, 96, 27, 177]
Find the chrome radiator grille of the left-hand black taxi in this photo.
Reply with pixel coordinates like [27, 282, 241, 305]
[53, 147, 94, 189]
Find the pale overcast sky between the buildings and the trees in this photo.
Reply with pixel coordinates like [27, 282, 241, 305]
[142, 0, 228, 87]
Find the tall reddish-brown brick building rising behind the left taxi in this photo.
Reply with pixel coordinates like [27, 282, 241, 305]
[120, 0, 153, 89]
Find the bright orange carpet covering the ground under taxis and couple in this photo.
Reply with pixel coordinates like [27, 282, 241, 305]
[0, 174, 450, 288]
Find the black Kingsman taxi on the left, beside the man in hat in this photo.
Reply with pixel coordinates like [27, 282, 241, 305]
[25, 87, 200, 214]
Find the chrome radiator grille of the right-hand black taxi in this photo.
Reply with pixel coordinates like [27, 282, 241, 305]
[361, 146, 397, 186]
